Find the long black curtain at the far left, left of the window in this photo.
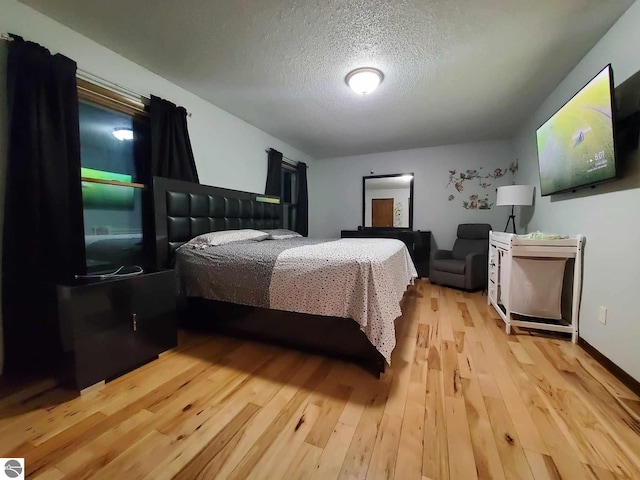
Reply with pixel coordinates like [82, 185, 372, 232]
[2, 36, 86, 372]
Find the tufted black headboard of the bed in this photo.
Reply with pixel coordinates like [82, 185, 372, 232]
[153, 177, 282, 268]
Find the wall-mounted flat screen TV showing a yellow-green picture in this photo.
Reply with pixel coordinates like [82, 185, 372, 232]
[536, 65, 619, 196]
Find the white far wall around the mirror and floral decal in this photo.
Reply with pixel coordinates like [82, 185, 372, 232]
[309, 141, 515, 248]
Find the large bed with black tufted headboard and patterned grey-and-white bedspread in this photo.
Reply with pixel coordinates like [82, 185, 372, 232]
[153, 177, 417, 374]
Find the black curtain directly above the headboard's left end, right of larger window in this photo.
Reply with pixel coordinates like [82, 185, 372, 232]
[149, 95, 199, 183]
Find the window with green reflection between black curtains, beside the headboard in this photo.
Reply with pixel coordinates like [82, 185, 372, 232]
[78, 80, 150, 273]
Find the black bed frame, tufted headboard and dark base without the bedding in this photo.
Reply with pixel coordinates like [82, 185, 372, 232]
[153, 177, 386, 376]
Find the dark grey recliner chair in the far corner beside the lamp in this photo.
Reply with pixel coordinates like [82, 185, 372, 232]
[429, 223, 491, 290]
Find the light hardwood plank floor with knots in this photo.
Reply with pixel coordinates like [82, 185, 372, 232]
[0, 281, 640, 480]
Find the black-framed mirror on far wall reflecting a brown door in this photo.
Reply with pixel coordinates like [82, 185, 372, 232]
[362, 173, 413, 229]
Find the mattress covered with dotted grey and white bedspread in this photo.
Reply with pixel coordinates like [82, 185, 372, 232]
[176, 237, 418, 362]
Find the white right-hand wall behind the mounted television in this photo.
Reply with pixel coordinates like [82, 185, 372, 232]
[514, 2, 640, 380]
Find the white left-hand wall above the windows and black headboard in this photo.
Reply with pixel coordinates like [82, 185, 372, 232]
[0, 0, 313, 373]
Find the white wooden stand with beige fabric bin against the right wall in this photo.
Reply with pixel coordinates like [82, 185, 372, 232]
[487, 232, 584, 343]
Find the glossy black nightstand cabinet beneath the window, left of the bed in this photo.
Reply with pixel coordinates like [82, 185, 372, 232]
[58, 270, 177, 390]
